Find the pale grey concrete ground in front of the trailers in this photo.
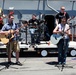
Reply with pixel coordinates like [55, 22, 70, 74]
[0, 57, 76, 75]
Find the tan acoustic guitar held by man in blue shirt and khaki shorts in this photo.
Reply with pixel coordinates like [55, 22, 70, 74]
[0, 21, 28, 44]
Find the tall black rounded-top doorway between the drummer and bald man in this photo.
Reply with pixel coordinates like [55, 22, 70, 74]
[44, 15, 55, 41]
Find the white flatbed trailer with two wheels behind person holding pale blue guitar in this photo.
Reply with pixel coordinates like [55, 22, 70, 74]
[34, 41, 76, 56]
